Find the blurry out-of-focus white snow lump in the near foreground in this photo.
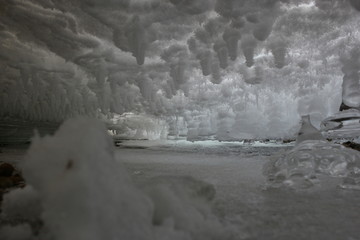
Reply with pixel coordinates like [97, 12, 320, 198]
[0, 118, 232, 240]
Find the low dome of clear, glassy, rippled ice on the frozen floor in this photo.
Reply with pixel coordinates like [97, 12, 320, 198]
[263, 140, 360, 190]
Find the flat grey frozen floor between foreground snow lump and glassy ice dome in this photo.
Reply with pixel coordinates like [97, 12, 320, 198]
[116, 141, 360, 240]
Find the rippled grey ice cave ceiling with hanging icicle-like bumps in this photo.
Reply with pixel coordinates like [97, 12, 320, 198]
[0, 0, 360, 139]
